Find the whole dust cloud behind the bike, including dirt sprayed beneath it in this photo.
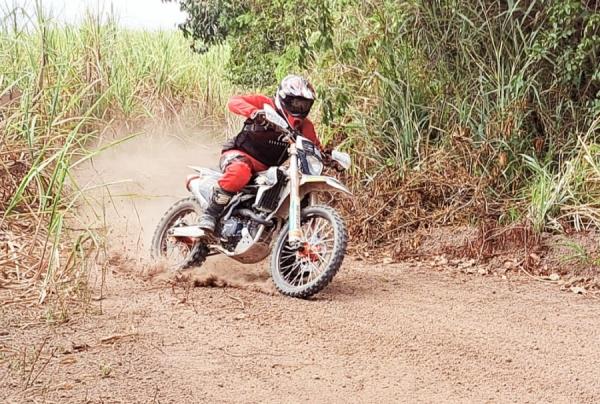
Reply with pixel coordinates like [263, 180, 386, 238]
[78, 121, 274, 294]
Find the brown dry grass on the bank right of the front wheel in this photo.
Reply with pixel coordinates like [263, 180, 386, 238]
[343, 148, 492, 248]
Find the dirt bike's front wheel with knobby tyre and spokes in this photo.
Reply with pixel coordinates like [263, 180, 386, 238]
[271, 206, 348, 298]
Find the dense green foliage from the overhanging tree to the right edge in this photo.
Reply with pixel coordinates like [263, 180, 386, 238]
[176, 0, 600, 234]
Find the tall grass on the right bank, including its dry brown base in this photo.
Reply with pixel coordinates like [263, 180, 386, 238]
[307, 0, 600, 238]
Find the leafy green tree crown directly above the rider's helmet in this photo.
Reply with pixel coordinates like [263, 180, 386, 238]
[166, 0, 331, 87]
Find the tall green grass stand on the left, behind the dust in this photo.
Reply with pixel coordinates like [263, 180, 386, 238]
[0, 8, 231, 300]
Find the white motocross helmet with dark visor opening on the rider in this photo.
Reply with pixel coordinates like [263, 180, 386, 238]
[275, 75, 316, 119]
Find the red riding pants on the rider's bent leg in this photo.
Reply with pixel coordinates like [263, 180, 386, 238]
[219, 150, 269, 193]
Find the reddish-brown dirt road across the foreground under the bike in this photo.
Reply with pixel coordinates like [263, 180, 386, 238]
[0, 260, 600, 403]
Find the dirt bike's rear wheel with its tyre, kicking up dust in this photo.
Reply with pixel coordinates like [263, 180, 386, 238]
[151, 198, 208, 269]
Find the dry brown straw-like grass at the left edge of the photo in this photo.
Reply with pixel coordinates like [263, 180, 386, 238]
[0, 140, 99, 304]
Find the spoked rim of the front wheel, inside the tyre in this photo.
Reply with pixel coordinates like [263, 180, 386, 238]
[277, 215, 335, 289]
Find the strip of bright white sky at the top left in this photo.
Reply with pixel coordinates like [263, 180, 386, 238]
[0, 0, 185, 29]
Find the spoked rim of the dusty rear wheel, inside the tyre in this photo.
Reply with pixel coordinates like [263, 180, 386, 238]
[160, 208, 198, 268]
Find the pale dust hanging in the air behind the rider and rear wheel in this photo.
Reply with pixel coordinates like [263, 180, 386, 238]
[79, 121, 221, 251]
